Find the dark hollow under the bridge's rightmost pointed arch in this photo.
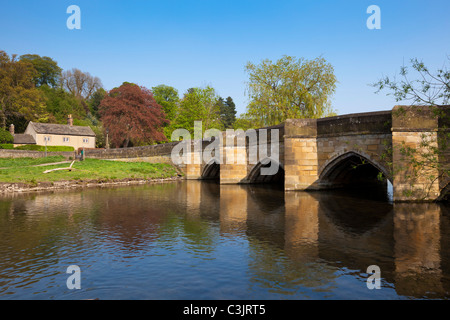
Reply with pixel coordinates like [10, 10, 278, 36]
[319, 152, 391, 192]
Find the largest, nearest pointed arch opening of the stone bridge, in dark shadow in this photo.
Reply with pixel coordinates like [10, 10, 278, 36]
[319, 151, 392, 188]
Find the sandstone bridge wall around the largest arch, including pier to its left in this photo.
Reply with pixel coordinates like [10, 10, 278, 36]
[285, 112, 391, 190]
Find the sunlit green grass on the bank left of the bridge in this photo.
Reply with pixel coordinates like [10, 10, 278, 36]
[0, 156, 178, 185]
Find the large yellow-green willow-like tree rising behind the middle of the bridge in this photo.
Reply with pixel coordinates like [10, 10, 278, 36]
[245, 56, 337, 127]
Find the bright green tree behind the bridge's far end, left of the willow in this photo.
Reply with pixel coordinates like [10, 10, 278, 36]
[174, 86, 223, 132]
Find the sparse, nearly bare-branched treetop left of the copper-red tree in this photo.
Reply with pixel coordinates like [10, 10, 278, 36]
[61, 68, 103, 100]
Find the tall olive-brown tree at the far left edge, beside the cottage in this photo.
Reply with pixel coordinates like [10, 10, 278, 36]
[0, 51, 46, 129]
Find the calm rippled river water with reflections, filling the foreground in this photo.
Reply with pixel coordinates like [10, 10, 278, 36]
[0, 181, 450, 300]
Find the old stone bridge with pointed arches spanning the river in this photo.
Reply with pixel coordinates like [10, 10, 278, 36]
[184, 106, 450, 201]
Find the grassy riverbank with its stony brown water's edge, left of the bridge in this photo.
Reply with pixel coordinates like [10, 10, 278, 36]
[0, 157, 183, 194]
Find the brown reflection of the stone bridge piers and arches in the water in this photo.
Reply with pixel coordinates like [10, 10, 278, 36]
[185, 182, 450, 297]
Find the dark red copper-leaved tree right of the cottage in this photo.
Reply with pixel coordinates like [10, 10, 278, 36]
[99, 82, 168, 148]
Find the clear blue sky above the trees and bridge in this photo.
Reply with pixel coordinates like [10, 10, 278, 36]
[0, 0, 450, 114]
